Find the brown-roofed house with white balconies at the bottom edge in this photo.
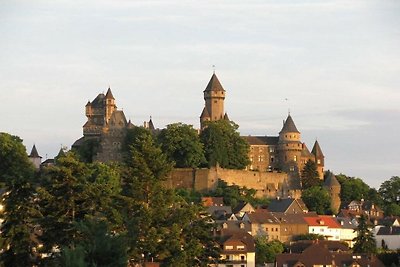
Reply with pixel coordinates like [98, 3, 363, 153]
[218, 231, 256, 267]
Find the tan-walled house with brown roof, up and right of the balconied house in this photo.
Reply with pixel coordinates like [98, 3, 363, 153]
[243, 209, 281, 241]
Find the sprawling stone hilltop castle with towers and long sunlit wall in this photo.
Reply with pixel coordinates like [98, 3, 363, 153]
[67, 73, 340, 211]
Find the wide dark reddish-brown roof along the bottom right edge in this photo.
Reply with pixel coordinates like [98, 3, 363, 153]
[275, 240, 384, 267]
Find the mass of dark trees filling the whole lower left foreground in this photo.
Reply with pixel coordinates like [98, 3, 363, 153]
[0, 127, 219, 266]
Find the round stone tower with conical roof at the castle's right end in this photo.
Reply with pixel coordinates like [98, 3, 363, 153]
[278, 114, 303, 175]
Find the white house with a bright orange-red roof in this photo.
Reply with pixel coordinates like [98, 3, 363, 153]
[304, 215, 341, 241]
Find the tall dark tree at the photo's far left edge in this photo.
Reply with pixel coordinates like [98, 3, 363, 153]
[0, 133, 37, 266]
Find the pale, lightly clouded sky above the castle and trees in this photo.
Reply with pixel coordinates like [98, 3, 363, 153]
[0, 0, 400, 188]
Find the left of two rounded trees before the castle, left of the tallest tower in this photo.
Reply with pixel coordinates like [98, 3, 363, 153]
[158, 123, 205, 168]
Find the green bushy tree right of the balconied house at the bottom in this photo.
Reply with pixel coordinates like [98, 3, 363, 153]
[255, 236, 284, 264]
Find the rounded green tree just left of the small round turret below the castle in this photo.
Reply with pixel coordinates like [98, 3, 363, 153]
[301, 186, 332, 214]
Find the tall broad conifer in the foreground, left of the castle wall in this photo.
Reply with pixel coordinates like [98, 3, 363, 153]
[121, 127, 218, 266]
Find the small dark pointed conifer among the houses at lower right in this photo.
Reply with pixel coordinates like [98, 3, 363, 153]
[353, 214, 376, 254]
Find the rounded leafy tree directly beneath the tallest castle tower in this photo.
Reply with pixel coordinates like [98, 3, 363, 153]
[200, 120, 250, 169]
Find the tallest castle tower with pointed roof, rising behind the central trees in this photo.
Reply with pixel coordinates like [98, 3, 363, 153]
[200, 73, 228, 128]
